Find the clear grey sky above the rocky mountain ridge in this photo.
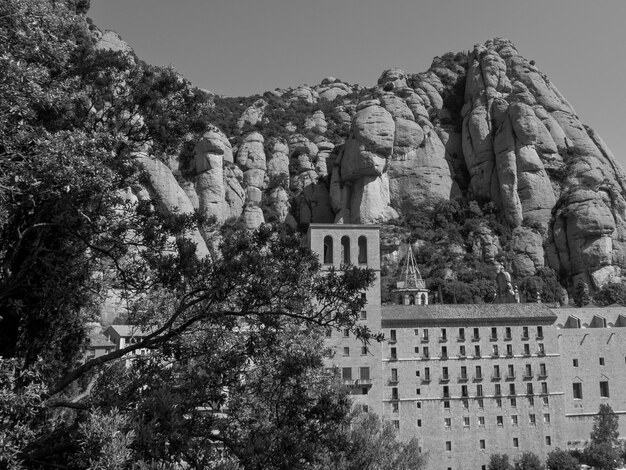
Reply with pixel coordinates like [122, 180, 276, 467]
[89, 0, 626, 167]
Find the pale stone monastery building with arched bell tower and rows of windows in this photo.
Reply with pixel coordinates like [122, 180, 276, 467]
[309, 224, 626, 470]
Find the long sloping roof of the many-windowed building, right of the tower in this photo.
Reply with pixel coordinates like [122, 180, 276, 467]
[382, 303, 557, 328]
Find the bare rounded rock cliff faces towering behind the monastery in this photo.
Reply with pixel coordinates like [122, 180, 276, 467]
[103, 35, 626, 288]
